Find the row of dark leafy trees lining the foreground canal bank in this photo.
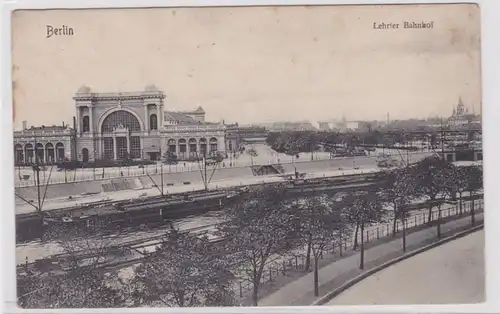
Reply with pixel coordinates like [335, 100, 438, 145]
[18, 157, 482, 308]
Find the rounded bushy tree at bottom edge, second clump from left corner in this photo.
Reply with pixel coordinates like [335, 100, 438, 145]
[135, 229, 232, 307]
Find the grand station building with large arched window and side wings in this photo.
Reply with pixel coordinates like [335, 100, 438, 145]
[14, 85, 226, 164]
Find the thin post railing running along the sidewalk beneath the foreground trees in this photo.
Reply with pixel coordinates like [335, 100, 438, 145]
[235, 200, 484, 298]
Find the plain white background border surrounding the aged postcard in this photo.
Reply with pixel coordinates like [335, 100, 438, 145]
[0, 0, 500, 313]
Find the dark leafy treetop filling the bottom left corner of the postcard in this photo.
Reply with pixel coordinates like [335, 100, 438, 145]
[18, 235, 121, 308]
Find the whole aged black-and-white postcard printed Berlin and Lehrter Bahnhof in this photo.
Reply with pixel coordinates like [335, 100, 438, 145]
[8, 3, 485, 309]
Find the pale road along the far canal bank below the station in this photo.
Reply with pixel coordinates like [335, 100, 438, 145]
[16, 154, 481, 214]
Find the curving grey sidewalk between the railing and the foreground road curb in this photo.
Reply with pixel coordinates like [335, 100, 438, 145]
[259, 213, 483, 306]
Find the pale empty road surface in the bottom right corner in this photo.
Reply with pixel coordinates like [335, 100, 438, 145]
[326, 230, 485, 305]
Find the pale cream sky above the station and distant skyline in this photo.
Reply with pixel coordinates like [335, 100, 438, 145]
[12, 4, 481, 127]
